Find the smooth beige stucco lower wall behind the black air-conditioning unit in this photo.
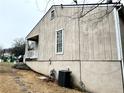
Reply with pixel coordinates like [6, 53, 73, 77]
[27, 61, 123, 93]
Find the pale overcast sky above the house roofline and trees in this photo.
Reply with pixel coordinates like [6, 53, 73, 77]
[0, 0, 124, 48]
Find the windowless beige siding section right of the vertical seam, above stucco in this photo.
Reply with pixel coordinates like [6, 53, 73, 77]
[80, 7, 118, 60]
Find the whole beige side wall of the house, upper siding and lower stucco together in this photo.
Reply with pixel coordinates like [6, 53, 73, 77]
[26, 6, 123, 93]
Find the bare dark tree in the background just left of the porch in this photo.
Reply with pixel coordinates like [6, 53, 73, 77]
[12, 38, 25, 57]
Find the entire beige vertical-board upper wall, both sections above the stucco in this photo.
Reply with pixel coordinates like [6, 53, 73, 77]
[26, 6, 117, 60]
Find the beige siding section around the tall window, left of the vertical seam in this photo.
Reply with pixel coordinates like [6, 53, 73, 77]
[39, 7, 79, 60]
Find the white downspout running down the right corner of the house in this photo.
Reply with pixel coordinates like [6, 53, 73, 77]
[113, 8, 124, 92]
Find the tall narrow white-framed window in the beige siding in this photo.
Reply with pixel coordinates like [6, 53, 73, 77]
[56, 30, 63, 54]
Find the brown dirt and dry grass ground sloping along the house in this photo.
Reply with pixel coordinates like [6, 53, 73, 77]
[0, 63, 82, 93]
